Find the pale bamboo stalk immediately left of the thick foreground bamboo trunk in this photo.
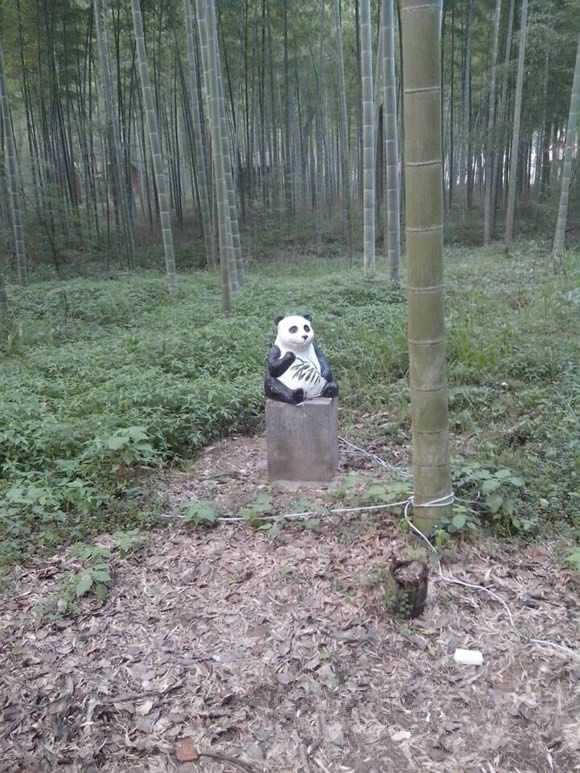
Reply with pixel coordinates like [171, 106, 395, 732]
[383, 0, 401, 287]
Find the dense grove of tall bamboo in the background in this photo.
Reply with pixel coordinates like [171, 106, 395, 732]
[0, 0, 580, 298]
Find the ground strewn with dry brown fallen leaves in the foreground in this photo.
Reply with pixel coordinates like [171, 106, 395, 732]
[0, 437, 580, 773]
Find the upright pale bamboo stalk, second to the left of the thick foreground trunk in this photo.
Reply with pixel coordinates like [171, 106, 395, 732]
[360, 0, 375, 274]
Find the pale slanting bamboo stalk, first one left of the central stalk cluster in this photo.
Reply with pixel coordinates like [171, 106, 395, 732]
[131, 0, 177, 295]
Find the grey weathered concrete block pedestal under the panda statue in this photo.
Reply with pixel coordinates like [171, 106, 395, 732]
[266, 397, 338, 482]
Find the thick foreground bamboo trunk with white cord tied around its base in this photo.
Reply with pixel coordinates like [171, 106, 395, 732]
[401, 0, 451, 532]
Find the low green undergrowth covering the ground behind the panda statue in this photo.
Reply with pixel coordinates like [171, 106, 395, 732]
[0, 243, 578, 564]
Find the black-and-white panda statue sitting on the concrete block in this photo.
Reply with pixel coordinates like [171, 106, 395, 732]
[264, 314, 338, 405]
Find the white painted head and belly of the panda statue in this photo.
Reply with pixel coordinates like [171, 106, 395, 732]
[274, 315, 326, 399]
